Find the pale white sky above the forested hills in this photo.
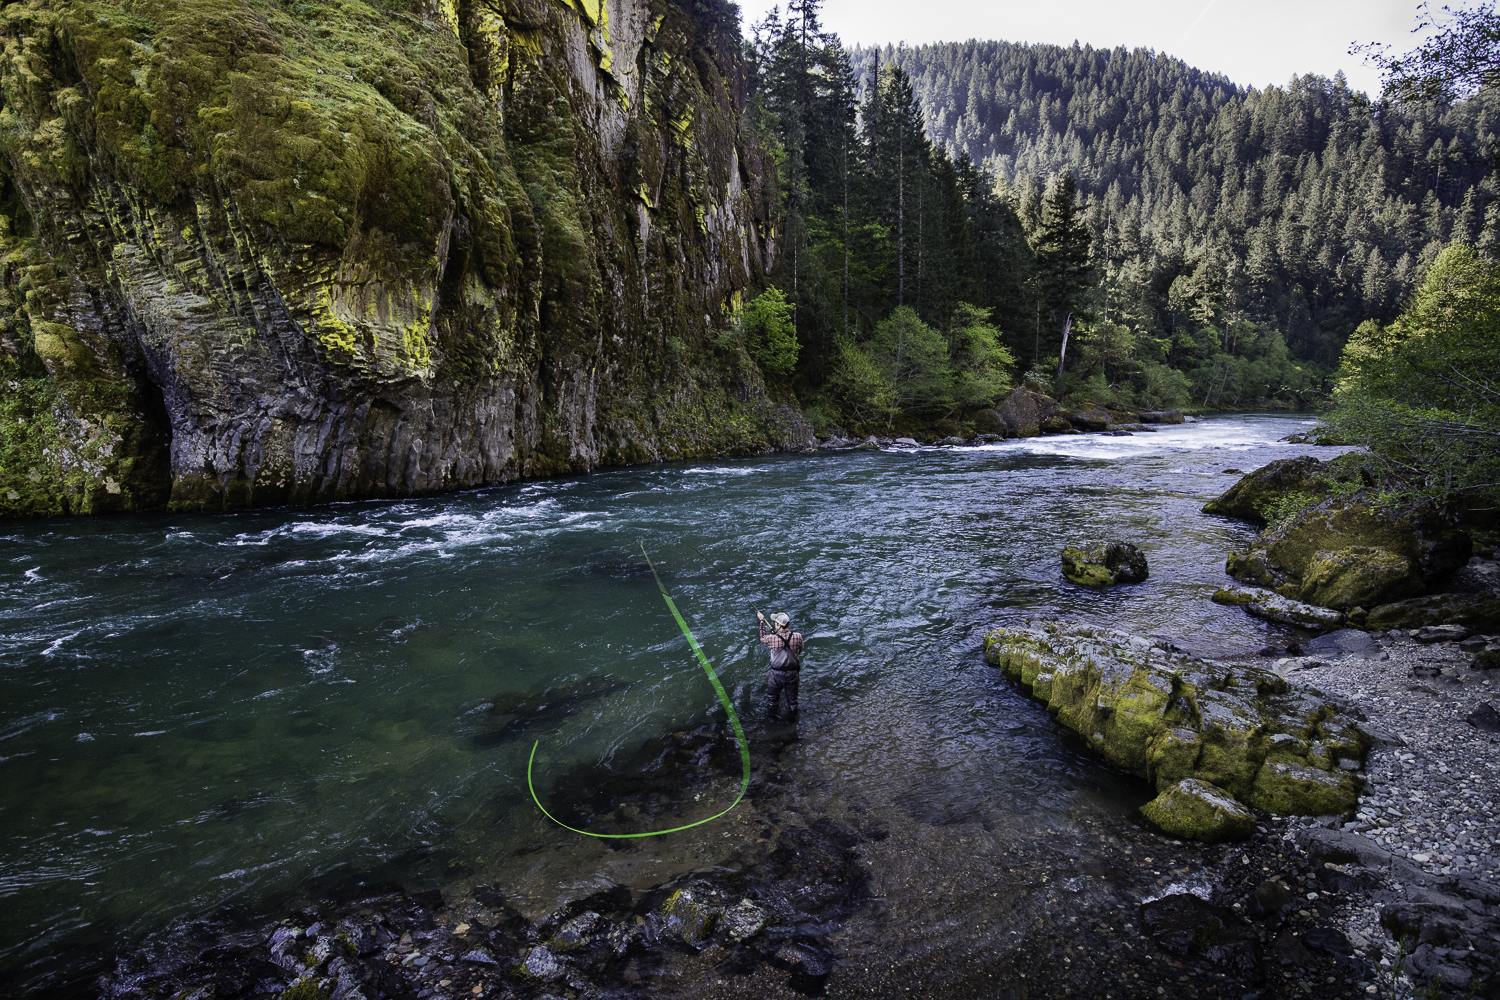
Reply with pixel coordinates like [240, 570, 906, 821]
[740, 0, 1440, 94]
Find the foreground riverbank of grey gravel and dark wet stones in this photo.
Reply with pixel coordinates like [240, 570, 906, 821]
[79, 636, 1500, 1000]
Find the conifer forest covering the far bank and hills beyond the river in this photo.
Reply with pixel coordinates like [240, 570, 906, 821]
[738, 0, 1500, 426]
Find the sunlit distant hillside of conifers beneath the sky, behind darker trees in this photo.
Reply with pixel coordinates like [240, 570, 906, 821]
[854, 42, 1500, 363]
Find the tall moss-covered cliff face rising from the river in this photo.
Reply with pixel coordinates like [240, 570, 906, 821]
[0, 0, 809, 516]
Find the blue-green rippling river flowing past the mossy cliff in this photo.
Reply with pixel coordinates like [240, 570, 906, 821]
[0, 417, 1329, 988]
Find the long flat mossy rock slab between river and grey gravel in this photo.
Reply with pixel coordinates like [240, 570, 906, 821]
[984, 622, 1370, 837]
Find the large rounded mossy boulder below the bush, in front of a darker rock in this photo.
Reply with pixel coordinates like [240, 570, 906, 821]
[1224, 498, 1472, 610]
